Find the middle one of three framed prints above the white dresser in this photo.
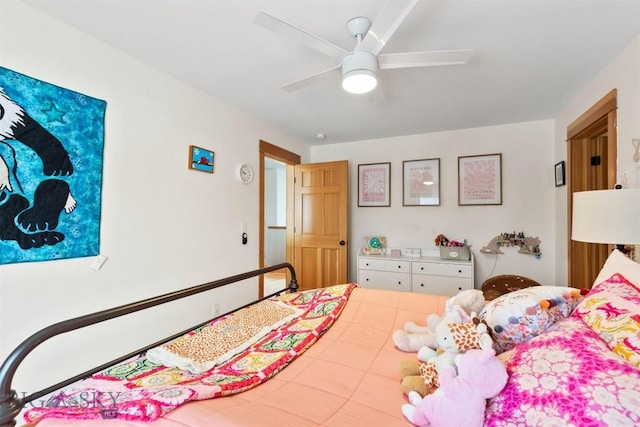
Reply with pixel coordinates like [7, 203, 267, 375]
[402, 159, 440, 206]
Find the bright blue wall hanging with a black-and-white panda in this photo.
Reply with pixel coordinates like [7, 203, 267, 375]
[0, 67, 106, 264]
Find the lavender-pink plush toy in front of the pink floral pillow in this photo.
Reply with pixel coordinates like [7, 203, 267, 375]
[402, 349, 508, 427]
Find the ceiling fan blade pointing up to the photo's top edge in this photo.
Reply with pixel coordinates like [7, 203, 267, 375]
[356, 0, 418, 55]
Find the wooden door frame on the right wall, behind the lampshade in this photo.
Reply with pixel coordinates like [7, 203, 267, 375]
[567, 89, 618, 285]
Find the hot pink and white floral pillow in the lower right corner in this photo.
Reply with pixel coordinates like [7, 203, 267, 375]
[485, 275, 640, 427]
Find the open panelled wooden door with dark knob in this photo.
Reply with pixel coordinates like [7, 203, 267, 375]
[293, 161, 348, 290]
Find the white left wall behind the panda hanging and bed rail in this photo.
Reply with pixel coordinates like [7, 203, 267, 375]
[0, 0, 309, 392]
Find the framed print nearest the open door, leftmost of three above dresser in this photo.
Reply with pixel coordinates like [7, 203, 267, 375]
[358, 162, 391, 207]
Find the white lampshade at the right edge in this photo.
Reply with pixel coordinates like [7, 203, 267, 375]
[571, 188, 640, 245]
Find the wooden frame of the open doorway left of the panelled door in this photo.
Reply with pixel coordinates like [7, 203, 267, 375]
[258, 139, 300, 298]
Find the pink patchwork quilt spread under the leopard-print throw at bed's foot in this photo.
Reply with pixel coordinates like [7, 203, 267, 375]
[24, 284, 356, 422]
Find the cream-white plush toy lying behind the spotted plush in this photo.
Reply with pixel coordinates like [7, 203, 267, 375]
[393, 289, 484, 353]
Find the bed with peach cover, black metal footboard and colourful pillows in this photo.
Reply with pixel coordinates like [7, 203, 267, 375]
[0, 251, 640, 427]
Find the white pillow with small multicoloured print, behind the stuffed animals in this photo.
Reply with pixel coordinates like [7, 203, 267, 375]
[479, 286, 588, 353]
